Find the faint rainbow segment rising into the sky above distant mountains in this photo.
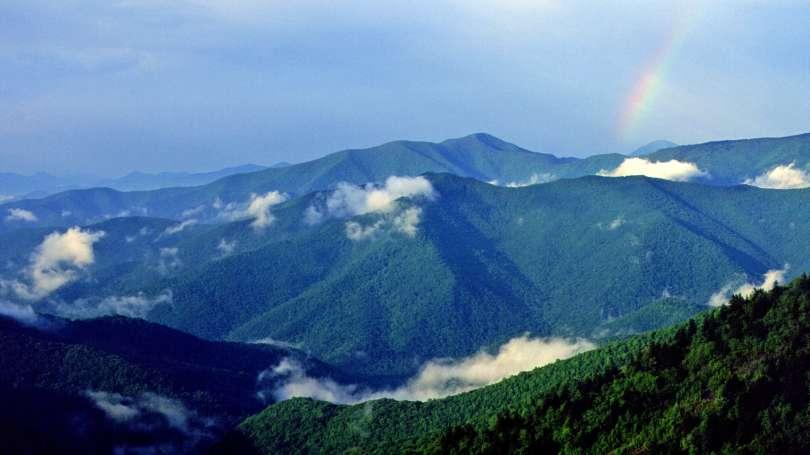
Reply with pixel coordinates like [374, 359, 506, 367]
[618, 15, 696, 141]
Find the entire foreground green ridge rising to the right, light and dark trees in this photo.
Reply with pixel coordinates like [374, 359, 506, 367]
[230, 276, 810, 454]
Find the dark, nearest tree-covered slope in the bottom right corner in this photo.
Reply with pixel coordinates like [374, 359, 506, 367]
[420, 276, 810, 454]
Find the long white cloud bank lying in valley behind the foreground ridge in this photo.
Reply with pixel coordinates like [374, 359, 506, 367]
[259, 335, 596, 403]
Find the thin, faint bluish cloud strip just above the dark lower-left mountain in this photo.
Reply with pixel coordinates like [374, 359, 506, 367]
[54, 290, 172, 319]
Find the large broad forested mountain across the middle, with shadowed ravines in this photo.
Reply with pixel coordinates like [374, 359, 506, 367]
[2, 174, 810, 382]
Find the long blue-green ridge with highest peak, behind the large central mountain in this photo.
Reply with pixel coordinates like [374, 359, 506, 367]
[0, 134, 608, 230]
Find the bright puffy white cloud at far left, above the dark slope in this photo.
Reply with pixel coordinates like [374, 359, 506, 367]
[4, 227, 104, 300]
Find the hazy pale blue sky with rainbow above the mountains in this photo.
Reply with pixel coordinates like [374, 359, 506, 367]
[0, 0, 810, 176]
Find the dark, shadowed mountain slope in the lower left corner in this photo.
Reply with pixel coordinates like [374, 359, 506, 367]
[0, 316, 341, 453]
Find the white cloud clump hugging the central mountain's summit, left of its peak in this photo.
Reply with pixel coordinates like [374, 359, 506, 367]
[304, 176, 436, 241]
